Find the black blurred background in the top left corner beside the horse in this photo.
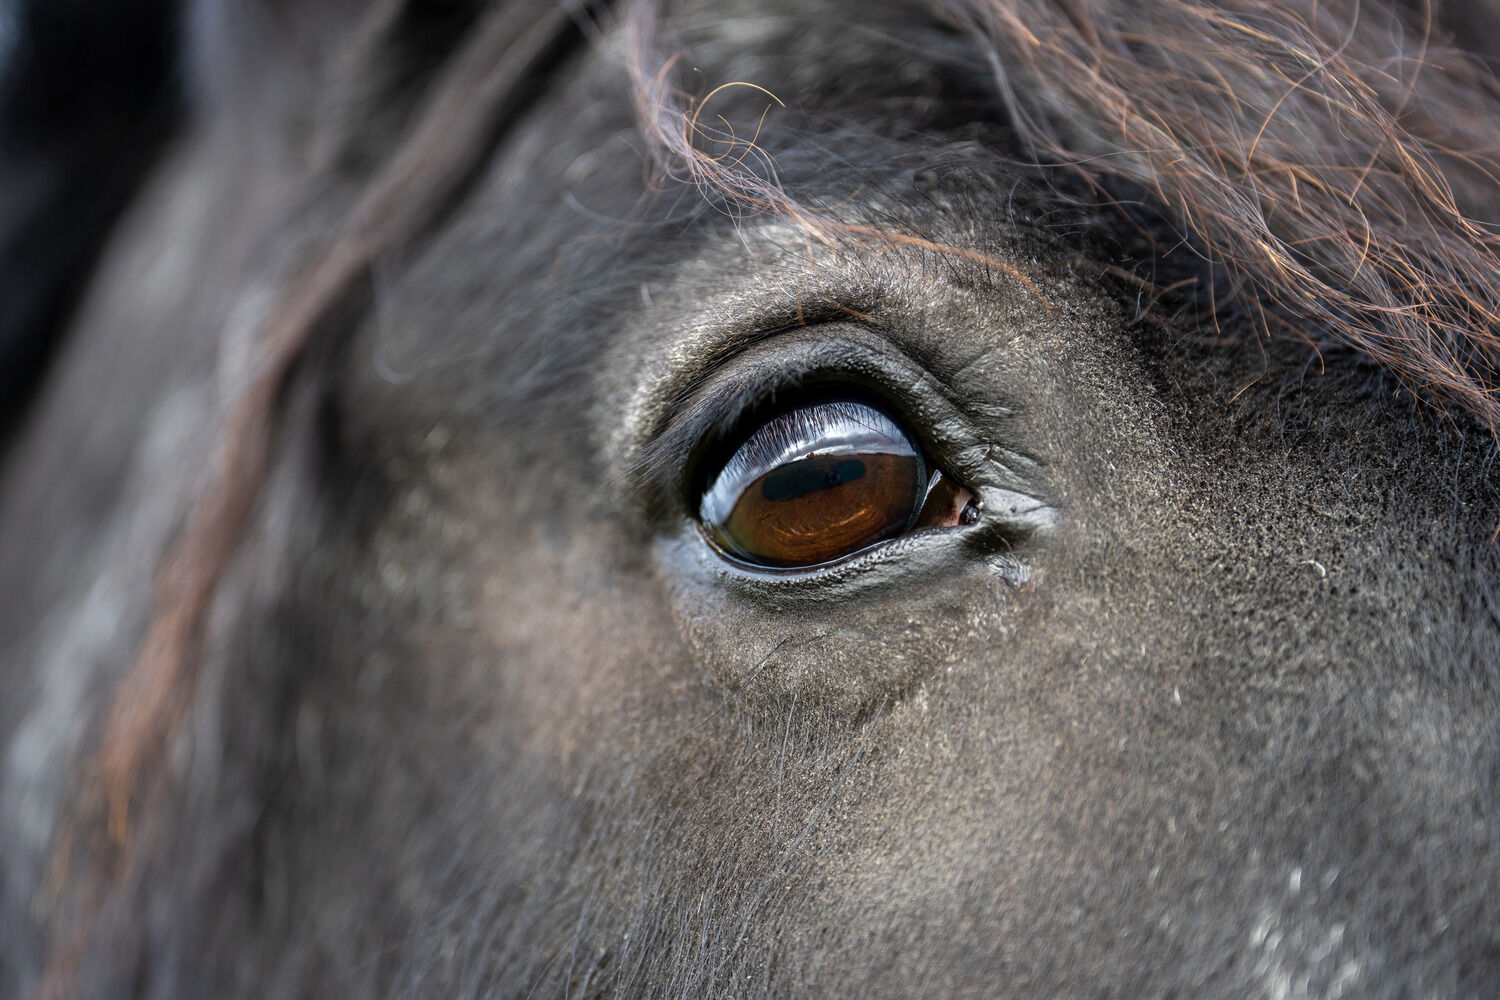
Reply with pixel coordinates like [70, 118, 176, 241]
[0, 0, 182, 454]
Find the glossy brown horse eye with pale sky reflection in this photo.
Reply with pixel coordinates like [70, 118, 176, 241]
[699, 402, 977, 568]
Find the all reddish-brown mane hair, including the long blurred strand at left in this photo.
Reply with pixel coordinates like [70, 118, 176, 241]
[42, 0, 1500, 996]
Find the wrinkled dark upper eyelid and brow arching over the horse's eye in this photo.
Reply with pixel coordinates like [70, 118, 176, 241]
[596, 248, 1044, 520]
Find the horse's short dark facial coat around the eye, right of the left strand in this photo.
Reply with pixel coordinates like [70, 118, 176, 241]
[5, 0, 1500, 997]
